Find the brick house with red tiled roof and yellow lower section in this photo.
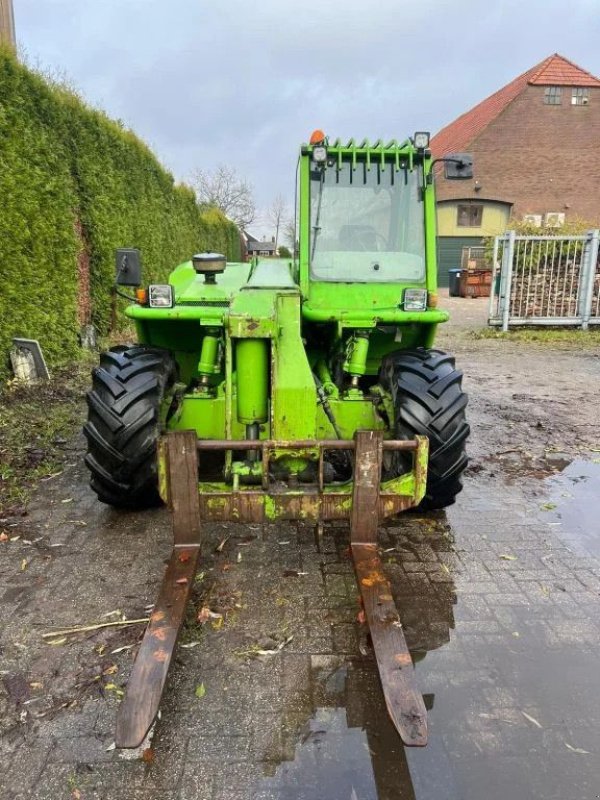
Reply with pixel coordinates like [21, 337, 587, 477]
[431, 53, 600, 286]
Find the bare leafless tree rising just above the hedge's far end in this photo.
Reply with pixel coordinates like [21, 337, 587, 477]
[193, 164, 256, 228]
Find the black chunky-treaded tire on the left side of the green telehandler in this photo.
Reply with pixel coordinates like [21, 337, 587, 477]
[83, 346, 177, 508]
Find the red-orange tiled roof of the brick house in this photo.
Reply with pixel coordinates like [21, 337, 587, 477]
[431, 53, 600, 158]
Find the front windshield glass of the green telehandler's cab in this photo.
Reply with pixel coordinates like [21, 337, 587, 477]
[310, 162, 425, 283]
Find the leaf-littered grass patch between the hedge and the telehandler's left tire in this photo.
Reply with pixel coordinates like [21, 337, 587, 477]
[0, 353, 97, 516]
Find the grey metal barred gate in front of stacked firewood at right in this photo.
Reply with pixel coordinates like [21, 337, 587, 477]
[489, 230, 600, 331]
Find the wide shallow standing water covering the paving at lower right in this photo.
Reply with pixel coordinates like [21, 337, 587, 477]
[256, 482, 600, 800]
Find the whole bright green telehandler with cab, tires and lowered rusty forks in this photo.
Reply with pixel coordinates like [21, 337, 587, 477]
[84, 131, 472, 747]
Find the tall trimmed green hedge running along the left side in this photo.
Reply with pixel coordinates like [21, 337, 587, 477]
[0, 50, 240, 376]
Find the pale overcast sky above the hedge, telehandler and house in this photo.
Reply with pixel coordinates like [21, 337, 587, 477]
[13, 0, 600, 232]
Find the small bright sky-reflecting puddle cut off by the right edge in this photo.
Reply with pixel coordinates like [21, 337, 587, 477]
[543, 459, 600, 556]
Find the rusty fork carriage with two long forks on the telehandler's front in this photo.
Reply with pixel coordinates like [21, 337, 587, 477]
[116, 431, 428, 747]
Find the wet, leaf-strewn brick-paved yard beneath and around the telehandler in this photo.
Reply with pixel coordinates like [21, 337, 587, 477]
[0, 301, 600, 800]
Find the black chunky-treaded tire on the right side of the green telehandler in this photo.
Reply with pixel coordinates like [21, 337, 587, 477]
[381, 348, 469, 510]
